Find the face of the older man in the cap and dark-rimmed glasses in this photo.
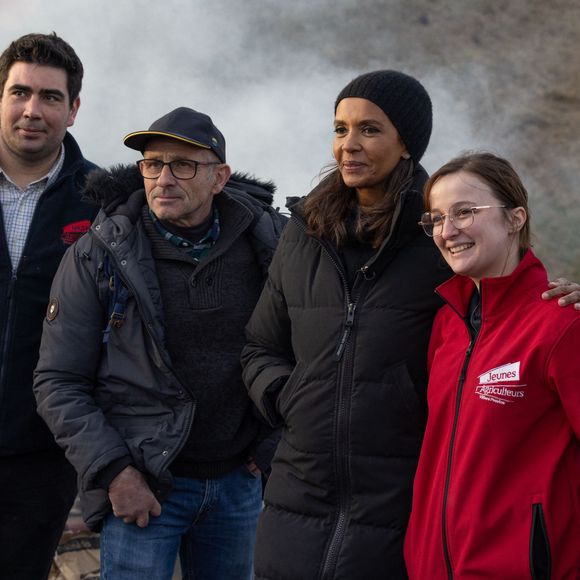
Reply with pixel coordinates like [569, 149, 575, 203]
[143, 138, 231, 228]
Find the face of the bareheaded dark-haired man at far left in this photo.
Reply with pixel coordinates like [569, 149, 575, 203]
[0, 62, 80, 164]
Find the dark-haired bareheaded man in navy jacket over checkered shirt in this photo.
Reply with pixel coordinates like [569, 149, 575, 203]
[0, 33, 96, 580]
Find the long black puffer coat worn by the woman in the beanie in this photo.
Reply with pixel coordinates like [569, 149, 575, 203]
[242, 169, 449, 580]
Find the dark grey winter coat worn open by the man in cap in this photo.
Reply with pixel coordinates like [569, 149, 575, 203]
[34, 167, 284, 529]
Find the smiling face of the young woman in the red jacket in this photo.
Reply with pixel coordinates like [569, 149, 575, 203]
[429, 171, 526, 286]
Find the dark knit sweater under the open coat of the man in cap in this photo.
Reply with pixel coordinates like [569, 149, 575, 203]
[143, 204, 262, 478]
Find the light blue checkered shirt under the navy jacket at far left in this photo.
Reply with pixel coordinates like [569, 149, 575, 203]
[0, 145, 64, 270]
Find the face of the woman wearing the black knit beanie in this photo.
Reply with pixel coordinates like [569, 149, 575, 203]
[332, 97, 408, 205]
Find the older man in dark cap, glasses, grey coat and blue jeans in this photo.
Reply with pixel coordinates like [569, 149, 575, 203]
[34, 107, 281, 580]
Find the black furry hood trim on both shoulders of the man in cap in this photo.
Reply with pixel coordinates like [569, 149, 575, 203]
[82, 164, 276, 211]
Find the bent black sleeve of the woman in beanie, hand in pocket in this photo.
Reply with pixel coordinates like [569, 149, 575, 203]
[241, 230, 295, 425]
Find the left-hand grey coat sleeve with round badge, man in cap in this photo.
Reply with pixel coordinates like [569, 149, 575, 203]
[34, 238, 130, 491]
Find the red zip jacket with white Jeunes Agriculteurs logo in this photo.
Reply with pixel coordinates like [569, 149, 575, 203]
[405, 251, 580, 580]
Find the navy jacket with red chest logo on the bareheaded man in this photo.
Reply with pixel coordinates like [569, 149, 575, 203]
[0, 133, 99, 456]
